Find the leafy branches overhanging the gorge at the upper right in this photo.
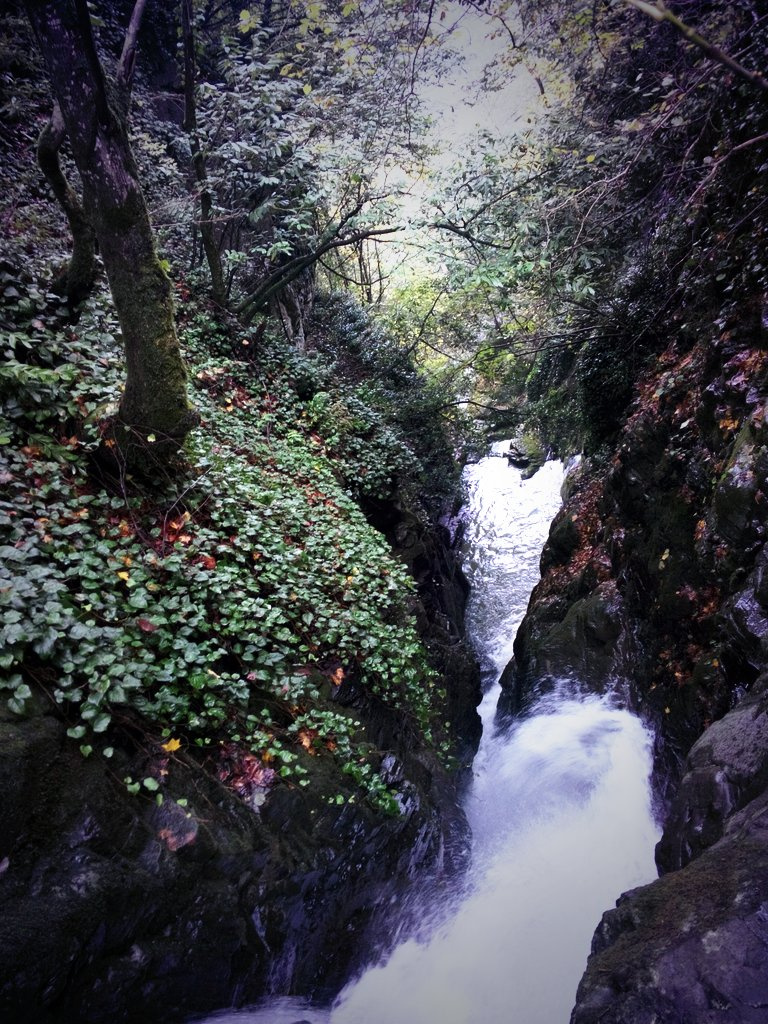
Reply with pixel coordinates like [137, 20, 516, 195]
[415, 0, 768, 451]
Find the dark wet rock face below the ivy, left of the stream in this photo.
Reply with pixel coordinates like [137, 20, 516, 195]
[0, 520, 479, 1024]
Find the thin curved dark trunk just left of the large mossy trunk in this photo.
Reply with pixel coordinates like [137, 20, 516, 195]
[37, 103, 96, 305]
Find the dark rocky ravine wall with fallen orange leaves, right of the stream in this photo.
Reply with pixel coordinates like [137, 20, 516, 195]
[501, 301, 768, 1011]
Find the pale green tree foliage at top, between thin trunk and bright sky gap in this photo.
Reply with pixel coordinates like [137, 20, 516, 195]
[153, 0, 460, 316]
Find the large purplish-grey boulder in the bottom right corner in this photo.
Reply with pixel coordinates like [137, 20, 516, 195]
[570, 795, 768, 1024]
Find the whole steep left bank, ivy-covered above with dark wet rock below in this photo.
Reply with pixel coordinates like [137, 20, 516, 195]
[0, 11, 479, 1024]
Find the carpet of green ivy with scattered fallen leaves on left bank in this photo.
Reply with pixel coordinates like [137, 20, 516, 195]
[0, 270, 456, 812]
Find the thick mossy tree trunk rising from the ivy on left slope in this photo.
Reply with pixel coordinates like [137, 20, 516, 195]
[25, 0, 196, 451]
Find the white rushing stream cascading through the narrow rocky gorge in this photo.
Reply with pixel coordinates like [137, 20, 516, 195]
[201, 442, 658, 1024]
